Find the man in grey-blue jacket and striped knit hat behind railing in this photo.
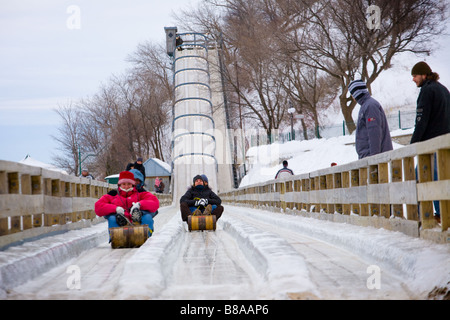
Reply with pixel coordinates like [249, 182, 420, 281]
[348, 80, 393, 159]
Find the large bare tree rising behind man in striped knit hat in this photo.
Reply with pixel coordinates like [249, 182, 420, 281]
[285, 0, 448, 132]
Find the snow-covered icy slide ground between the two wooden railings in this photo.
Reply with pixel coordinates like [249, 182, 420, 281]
[0, 206, 450, 300]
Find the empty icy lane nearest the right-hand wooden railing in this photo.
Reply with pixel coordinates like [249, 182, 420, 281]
[225, 209, 419, 299]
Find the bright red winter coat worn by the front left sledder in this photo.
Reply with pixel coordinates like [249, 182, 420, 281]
[95, 188, 159, 218]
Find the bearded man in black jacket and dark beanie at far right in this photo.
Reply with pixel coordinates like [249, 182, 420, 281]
[411, 62, 450, 143]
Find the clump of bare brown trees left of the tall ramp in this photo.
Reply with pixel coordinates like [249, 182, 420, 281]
[56, 43, 172, 176]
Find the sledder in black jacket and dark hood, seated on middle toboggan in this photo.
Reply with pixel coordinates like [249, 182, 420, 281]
[180, 175, 223, 222]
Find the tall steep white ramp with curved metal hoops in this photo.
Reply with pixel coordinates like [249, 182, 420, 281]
[172, 33, 217, 205]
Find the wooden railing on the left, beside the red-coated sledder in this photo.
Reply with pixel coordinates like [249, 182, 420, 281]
[0, 160, 172, 248]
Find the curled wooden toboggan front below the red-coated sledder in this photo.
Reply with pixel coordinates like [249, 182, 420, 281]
[109, 224, 148, 249]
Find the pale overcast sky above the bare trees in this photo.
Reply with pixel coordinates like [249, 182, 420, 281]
[0, 0, 450, 168]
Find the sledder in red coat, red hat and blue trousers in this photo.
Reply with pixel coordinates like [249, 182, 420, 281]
[95, 171, 159, 237]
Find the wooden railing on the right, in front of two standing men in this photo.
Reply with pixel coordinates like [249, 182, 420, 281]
[220, 134, 450, 243]
